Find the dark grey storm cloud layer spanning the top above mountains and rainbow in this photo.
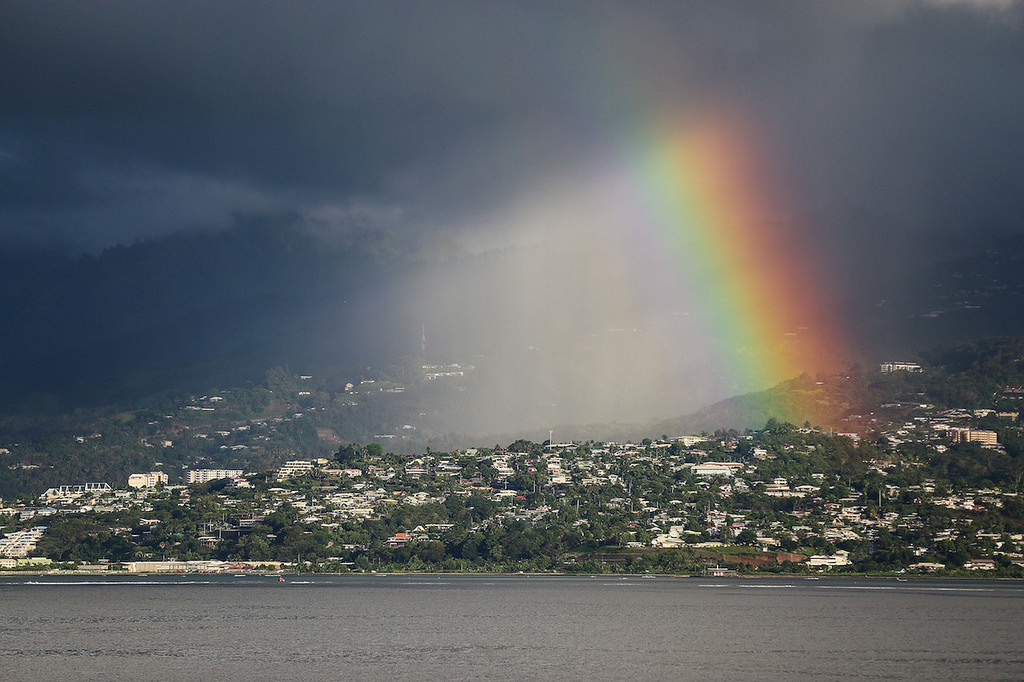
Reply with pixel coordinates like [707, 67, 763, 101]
[0, 2, 1024, 247]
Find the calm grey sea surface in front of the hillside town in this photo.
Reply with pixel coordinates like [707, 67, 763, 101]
[0, 576, 1024, 680]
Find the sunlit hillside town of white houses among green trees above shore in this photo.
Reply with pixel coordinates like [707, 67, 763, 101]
[0, 356, 1024, 578]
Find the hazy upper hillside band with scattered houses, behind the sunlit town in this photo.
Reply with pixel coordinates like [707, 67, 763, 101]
[0, 329, 1024, 499]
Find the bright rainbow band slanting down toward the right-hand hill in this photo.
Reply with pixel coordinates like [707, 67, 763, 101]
[629, 115, 849, 417]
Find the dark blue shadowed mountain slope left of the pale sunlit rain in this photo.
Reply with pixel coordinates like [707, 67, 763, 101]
[0, 218, 412, 408]
